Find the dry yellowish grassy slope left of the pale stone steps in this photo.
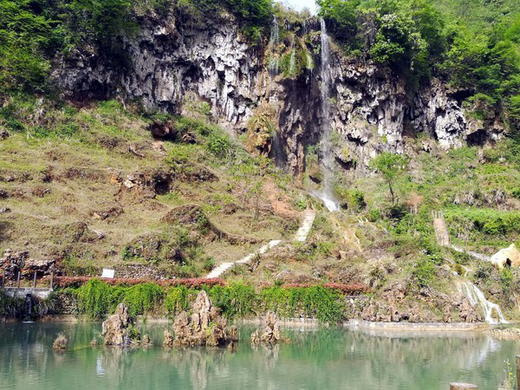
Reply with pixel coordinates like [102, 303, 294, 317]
[0, 100, 298, 276]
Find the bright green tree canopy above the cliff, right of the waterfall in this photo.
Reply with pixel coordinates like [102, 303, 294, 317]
[317, 0, 520, 128]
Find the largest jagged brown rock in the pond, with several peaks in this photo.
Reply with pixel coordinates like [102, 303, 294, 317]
[174, 291, 238, 347]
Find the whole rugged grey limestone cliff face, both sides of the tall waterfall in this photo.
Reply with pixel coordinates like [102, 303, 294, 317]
[54, 14, 500, 175]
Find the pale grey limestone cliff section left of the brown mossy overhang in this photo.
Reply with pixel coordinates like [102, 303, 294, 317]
[55, 15, 260, 125]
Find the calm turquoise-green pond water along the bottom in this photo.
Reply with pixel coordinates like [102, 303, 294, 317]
[0, 323, 520, 390]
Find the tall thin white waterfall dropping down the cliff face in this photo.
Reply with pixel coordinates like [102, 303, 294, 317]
[313, 19, 339, 212]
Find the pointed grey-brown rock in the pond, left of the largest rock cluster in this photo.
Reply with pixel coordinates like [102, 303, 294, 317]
[101, 303, 139, 346]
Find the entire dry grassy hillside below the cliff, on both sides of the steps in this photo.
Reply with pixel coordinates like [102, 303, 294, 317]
[0, 94, 520, 318]
